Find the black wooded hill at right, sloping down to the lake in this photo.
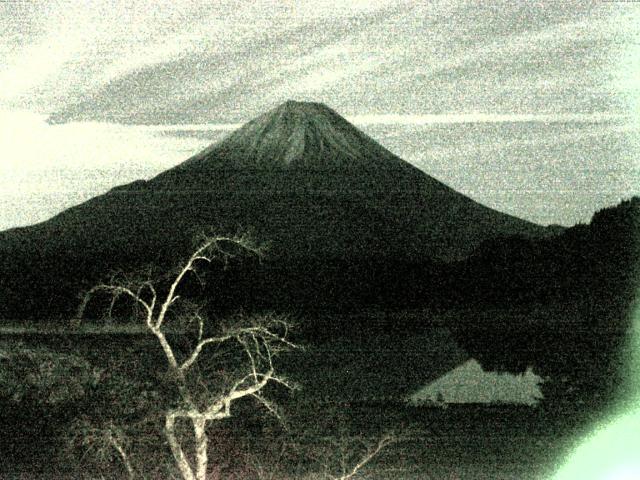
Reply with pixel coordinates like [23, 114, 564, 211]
[456, 197, 640, 305]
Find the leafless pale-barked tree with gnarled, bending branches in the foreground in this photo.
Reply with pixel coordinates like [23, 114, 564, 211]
[78, 236, 297, 480]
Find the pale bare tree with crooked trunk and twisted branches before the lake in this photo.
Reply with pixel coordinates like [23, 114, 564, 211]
[78, 237, 296, 480]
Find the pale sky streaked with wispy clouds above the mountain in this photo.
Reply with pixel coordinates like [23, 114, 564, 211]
[0, 0, 640, 229]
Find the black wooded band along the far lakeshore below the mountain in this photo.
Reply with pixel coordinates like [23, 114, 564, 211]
[0, 198, 640, 327]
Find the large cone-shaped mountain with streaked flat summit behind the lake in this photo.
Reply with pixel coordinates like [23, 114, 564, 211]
[0, 101, 550, 318]
